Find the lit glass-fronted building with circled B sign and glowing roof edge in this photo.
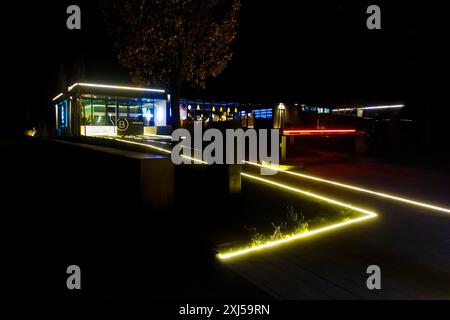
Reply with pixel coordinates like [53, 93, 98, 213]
[53, 83, 170, 136]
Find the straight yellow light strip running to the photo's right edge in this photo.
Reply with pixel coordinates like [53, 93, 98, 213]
[243, 161, 450, 213]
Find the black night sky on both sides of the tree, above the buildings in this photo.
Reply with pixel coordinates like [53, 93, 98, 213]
[3, 0, 450, 136]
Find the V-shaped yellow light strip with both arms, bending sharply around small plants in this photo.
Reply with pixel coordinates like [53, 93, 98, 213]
[217, 173, 377, 260]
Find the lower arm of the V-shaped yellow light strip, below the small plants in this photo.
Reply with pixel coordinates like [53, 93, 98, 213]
[217, 215, 376, 260]
